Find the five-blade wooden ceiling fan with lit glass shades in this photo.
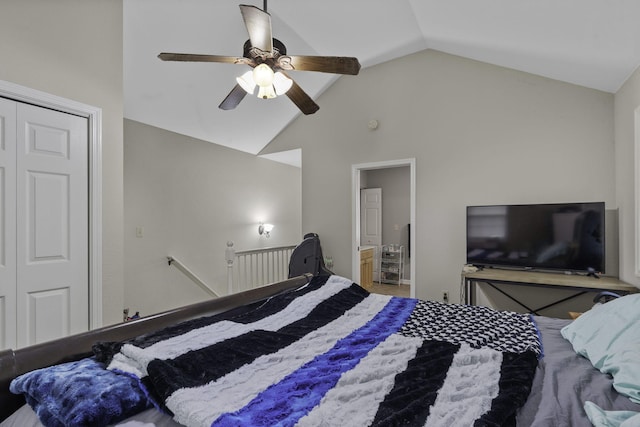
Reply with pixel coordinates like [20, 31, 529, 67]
[158, 0, 360, 114]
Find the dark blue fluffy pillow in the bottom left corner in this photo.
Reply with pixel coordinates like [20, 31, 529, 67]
[9, 358, 151, 427]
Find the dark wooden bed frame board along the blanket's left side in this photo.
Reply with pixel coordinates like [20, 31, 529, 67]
[0, 274, 312, 421]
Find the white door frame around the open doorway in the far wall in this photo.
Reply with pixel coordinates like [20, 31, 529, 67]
[351, 158, 418, 298]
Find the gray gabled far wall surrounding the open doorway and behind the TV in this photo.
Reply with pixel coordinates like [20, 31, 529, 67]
[264, 50, 616, 310]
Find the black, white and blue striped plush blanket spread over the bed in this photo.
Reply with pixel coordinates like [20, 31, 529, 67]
[95, 276, 541, 427]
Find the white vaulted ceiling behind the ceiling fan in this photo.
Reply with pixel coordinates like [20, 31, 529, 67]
[124, 0, 640, 157]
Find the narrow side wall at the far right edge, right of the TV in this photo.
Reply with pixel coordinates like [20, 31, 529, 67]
[615, 69, 640, 287]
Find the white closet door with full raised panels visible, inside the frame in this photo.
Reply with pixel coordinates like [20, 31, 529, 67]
[16, 103, 89, 347]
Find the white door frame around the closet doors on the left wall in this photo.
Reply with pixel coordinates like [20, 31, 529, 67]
[0, 80, 102, 329]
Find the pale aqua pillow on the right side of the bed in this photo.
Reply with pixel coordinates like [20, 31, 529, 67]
[561, 293, 640, 403]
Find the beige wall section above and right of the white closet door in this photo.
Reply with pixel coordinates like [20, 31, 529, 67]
[0, 0, 123, 324]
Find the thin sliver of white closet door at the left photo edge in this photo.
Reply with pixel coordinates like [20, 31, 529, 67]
[0, 98, 16, 349]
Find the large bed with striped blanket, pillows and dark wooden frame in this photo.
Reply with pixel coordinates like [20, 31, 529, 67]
[0, 275, 640, 427]
